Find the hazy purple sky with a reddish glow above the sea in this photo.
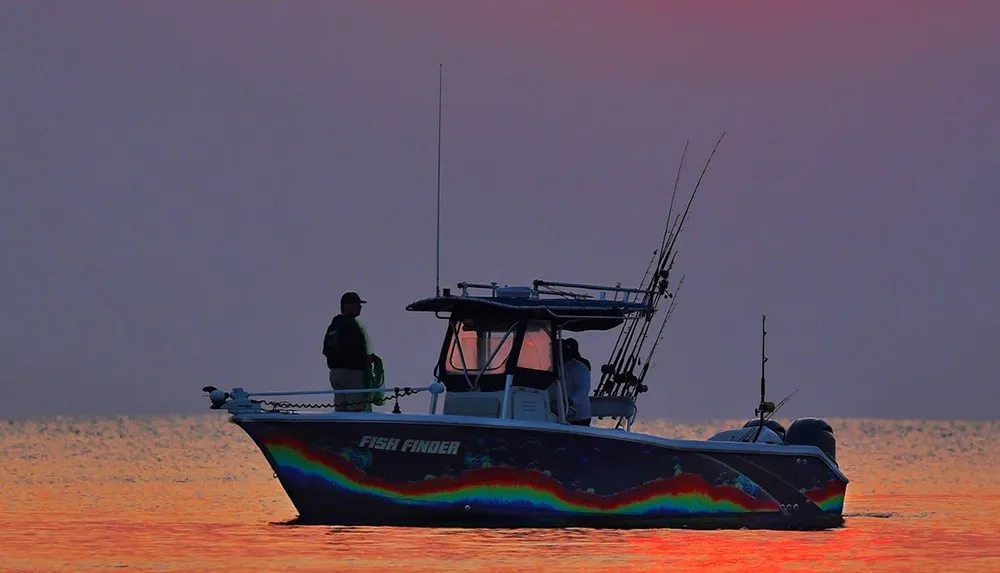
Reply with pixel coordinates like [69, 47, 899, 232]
[0, 0, 1000, 419]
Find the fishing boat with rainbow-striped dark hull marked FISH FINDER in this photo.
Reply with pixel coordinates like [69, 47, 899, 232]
[203, 130, 848, 529]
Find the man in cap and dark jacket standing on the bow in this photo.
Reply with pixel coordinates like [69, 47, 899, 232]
[323, 292, 375, 412]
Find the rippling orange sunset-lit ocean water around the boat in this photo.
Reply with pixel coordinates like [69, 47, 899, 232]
[0, 413, 1000, 573]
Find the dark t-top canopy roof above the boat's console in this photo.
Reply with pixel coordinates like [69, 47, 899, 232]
[406, 295, 647, 332]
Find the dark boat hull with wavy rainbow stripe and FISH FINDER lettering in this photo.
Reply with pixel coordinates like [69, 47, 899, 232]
[233, 414, 847, 529]
